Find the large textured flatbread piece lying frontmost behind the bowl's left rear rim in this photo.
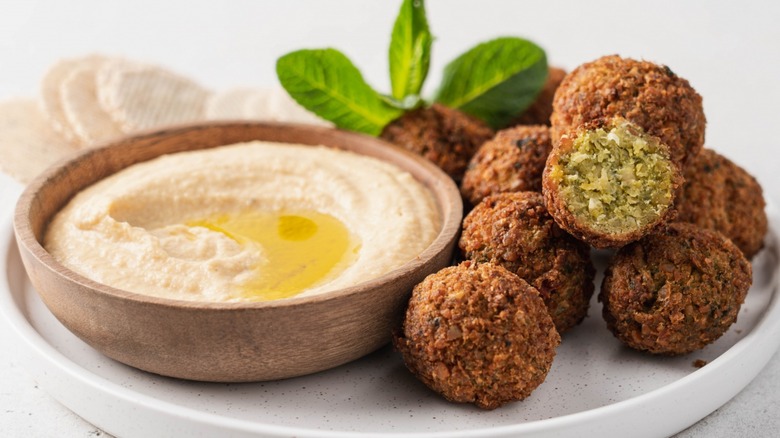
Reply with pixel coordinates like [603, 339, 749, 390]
[96, 60, 210, 132]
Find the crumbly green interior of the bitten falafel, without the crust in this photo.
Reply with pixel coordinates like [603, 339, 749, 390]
[549, 118, 677, 234]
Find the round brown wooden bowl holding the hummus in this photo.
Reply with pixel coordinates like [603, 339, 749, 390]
[14, 122, 463, 382]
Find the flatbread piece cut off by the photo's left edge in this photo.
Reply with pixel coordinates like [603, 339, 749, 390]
[0, 99, 77, 184]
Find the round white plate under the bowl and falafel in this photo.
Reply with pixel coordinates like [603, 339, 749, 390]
[0, 211, 780, 437]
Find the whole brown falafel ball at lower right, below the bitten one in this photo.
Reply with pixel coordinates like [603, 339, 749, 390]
[599, 222, 752, 355]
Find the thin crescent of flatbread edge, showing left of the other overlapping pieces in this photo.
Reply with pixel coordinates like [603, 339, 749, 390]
[40, 55, 105, 141]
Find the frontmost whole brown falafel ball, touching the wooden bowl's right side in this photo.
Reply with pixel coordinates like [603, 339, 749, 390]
[394, 261, 561, 409]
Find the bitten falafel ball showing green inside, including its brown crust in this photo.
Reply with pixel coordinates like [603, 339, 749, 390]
[542, 117, 682, 248]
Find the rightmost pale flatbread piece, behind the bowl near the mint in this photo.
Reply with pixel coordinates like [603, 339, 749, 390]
[244, 88, 333, 126]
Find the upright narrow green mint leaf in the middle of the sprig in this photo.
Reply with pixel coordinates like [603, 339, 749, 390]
[389, 0, 433, 101]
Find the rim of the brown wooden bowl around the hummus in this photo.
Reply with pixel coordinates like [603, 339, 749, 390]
[13, 120, 463, 311]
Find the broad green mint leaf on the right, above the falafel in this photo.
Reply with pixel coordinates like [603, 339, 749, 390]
[435, 37, 547, 129]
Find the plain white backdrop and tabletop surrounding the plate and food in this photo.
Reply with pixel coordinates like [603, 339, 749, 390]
[0, 0, 780, 438]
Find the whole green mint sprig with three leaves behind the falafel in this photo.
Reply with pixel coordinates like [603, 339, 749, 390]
[276, 0, 547, 136]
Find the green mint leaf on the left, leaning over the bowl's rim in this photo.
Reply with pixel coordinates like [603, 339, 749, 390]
[276, 49, 403, 135]
